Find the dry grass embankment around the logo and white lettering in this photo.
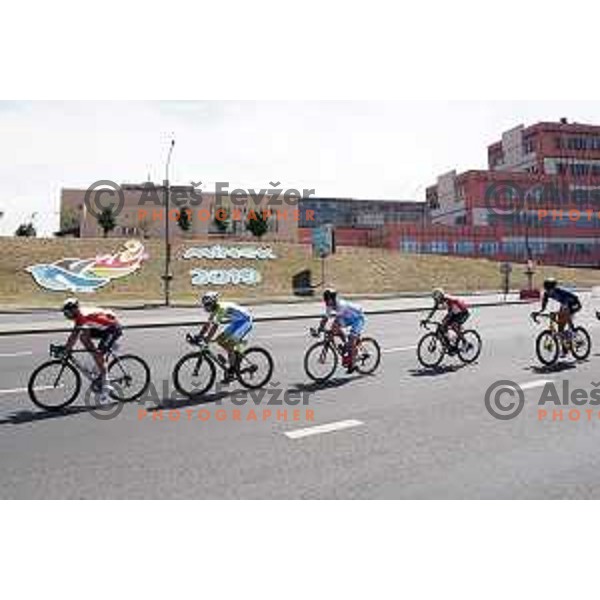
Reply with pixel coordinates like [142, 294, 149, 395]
[0, 238, 600, 307]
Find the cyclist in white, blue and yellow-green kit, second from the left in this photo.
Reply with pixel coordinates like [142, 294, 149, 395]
[200, 292, 253, 384]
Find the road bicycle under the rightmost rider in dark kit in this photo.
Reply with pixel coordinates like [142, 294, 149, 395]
[531, 313, 592, 367]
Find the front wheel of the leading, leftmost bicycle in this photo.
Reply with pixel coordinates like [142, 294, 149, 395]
[27, 360, 81, 411]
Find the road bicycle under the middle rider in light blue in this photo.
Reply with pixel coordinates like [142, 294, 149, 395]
[304, 330, 381, 383]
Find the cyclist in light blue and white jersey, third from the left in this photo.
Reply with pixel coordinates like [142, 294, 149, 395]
[316, 289, 365, 373]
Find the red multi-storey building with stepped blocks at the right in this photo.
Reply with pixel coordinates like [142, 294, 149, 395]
[398, 120, 600, 266]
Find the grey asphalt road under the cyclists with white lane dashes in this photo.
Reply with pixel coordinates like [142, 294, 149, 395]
[0, 306, 600, 499]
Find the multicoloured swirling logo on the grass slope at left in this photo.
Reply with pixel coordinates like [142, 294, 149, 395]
[26, 240, 148, 293]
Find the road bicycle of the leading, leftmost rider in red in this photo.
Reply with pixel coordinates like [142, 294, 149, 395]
[27, 344, 150, 411]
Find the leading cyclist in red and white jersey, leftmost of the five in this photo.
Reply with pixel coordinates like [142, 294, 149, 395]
[63, 298, 122, 402]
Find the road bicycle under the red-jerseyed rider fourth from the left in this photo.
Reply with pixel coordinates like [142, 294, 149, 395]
[417, 321, 482, 369]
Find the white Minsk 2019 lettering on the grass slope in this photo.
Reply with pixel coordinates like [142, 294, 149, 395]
[182, 246, 277, 286]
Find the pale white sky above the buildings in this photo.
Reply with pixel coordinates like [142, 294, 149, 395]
[0, 100, 600, 235]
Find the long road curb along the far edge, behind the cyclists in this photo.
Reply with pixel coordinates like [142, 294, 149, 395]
[0, 300, 528, 338]
